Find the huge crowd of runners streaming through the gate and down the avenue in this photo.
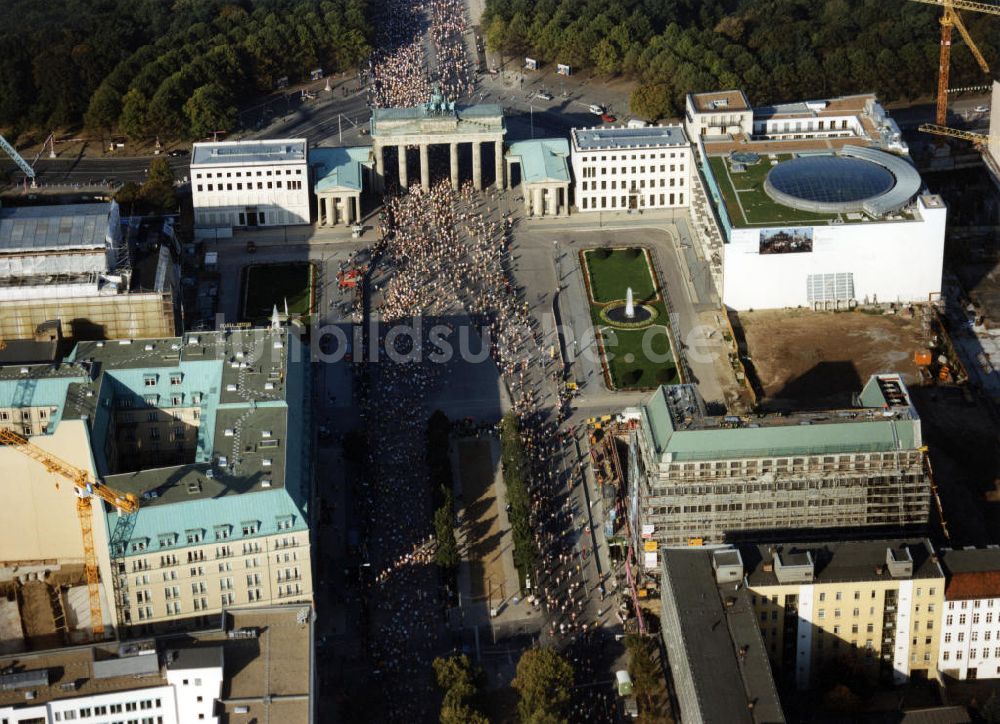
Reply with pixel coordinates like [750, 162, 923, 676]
[348, 0, 611, 723]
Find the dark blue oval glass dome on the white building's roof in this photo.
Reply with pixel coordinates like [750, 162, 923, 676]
[764, 156, 896, 212]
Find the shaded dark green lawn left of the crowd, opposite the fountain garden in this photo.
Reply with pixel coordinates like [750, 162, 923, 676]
[240, 262, 314, 324]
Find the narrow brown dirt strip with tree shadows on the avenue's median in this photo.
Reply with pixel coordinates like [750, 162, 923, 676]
[458, 440, 504, 600]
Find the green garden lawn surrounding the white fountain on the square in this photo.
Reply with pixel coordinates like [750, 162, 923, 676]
[584, 249, 679, 390]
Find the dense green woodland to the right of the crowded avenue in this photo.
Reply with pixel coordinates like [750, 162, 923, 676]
[483, 0, 1000, 117]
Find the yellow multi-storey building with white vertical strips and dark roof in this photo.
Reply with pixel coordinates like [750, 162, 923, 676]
[740, 539, 945, 688]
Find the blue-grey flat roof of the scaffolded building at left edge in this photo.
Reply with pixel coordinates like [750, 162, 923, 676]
[0, 204, 111, 254]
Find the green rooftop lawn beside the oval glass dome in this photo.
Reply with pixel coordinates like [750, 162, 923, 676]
[708, 154, 840, 226]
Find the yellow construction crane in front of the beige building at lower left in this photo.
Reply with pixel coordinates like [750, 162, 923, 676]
[0, 428, 139, 636]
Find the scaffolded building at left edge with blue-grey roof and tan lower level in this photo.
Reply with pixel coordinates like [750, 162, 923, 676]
[0, 201, 177, 340]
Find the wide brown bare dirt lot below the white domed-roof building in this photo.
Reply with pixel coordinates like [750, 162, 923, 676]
[730, 308, 930, 410]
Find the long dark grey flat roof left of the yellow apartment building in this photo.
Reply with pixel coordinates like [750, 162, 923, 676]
[663, 549, 785, 724]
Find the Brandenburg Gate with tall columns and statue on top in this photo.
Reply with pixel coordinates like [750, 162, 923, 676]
[371, 92, 506, 191]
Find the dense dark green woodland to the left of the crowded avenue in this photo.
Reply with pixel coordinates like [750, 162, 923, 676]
[0, 0, 370, 139]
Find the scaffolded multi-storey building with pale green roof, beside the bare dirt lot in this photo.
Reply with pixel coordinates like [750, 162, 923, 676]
[626, 374, 930, 556]
